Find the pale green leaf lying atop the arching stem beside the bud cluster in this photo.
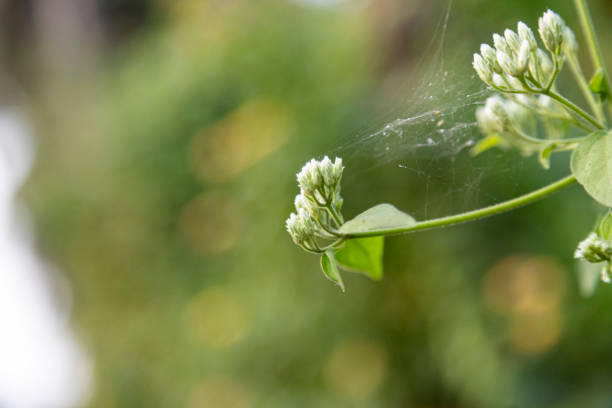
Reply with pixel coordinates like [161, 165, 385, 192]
[340, 204, 416, 234]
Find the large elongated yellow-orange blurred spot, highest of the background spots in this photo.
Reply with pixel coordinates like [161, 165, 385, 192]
[189, 100, 290, 182]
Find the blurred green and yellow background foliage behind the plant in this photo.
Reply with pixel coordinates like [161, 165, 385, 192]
[0, 0, 612, 408]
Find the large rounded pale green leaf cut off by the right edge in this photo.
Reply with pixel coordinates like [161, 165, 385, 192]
[571, 131, 612, 207]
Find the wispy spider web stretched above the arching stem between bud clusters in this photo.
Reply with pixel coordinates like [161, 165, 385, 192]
[330, 1, 537, 219]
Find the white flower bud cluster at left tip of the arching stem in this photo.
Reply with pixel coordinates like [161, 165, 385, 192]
[286, 156, 344, 252]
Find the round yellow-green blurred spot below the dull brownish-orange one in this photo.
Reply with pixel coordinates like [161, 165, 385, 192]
[184, 287, 250, 348]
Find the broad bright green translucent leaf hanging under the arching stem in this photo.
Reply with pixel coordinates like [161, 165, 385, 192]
[335, 237, 385, 280]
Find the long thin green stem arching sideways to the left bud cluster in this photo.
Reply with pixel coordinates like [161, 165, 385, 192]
[346, 175, 576, 238]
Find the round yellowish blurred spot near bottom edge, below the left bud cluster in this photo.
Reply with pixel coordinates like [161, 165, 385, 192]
[324, 339, 387, 399]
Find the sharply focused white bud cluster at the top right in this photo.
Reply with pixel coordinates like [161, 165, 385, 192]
[473, 10, 577, 93]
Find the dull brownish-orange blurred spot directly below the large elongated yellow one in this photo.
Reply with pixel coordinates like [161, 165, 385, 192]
[179, 192, 242, 254]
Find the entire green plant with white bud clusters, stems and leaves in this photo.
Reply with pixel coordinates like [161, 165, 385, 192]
[286, 0, 612, 290]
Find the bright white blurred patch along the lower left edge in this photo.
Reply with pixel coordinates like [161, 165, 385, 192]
[0, 109, 92, 408]
